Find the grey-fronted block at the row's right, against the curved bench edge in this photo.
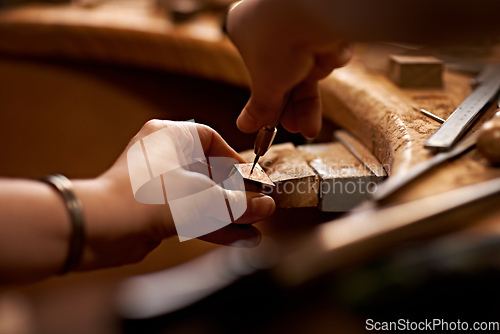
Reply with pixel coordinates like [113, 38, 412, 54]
[297, 142, 380, 212]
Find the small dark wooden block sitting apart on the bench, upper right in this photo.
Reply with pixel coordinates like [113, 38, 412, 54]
[388, 55, 443, 88]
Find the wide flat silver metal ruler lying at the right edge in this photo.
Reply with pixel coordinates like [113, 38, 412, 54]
[425, 64, 500, 151]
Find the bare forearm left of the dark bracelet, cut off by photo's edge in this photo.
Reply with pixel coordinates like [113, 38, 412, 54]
[0, 179, 70, 282]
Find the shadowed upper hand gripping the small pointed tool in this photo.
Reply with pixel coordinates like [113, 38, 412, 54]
[226, 0, 351, 138]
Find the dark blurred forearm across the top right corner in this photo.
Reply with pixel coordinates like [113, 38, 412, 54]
[292, 0, 500, 44]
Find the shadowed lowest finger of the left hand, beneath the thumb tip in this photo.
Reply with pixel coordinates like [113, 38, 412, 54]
[198, 224, 262, 248]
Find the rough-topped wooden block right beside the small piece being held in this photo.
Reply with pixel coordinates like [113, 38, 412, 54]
[240, 143, 319, 208]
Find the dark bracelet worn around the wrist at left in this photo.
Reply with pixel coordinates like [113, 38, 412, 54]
[42, 174, 85, 275]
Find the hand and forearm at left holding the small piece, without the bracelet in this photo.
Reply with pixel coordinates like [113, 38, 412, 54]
[0, 120, 275, 284]
